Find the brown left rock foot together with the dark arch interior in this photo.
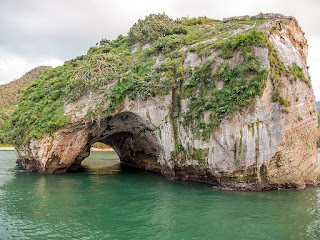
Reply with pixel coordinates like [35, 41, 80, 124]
[17, 111, 163, 172]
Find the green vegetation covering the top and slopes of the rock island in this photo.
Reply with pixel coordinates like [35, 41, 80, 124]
[7, 14, 312, 146]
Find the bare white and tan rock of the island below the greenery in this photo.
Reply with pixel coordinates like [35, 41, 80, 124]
[16, 15, 320, 190]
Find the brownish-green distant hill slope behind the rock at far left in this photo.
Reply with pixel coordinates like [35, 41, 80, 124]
[0, 66, 52, 112]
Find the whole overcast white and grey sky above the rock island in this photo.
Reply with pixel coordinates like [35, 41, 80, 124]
[0, 0, 320, 100]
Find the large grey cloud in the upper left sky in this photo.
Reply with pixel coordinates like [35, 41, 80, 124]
[0, 1, 136, 59]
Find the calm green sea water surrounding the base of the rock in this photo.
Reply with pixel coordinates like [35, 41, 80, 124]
[0, 151, 320, 240]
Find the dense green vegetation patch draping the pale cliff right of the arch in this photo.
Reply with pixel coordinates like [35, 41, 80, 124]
[183, 29, 268, 140]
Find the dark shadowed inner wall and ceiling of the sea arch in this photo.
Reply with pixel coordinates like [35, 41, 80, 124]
[70, 112, 162, 170]
